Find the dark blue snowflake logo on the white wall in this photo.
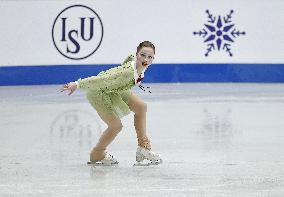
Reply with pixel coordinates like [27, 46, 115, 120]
[193, 10, 246, 57]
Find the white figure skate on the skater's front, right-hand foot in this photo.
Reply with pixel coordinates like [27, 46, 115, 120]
[134, 146, 162, 166]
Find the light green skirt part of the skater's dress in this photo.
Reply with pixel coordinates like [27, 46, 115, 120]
[86, 90, 131, 118]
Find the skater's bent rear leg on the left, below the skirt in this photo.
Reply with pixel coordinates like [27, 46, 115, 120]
[90, 113, 122, 162]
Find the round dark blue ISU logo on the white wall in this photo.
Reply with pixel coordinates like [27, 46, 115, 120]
[52, 5, 103, 60]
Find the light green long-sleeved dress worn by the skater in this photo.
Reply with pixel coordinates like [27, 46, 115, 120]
[78, 55, 135, 118]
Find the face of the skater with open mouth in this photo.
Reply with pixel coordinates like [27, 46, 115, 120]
[136, 47, 155, 69]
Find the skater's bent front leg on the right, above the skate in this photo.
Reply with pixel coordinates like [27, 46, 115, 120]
[128, 93, 151, 150]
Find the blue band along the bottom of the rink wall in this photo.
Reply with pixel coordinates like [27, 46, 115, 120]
[0, 64, 284, 85]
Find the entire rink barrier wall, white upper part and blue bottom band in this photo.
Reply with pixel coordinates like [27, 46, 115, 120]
[0, 0, 284, 85]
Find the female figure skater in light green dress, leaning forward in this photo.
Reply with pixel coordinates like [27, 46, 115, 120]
[61, 41, 162, 165]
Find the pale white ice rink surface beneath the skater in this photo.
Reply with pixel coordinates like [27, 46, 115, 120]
[0, 83, 284, 197]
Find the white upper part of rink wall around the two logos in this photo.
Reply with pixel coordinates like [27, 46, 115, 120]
[0, 0, 284, 66]
